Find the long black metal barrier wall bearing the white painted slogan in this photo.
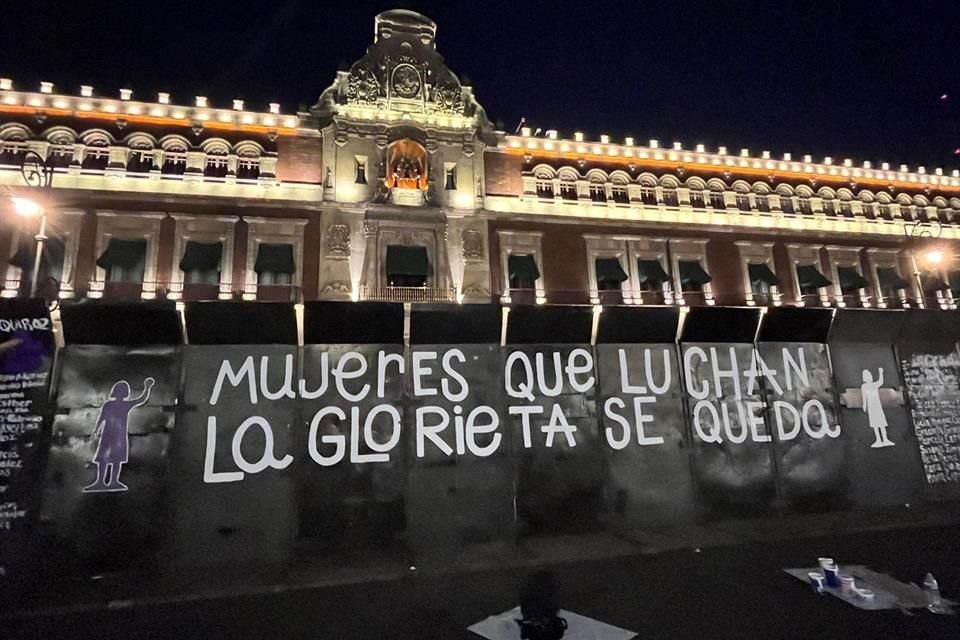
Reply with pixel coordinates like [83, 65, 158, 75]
[20, 303, 960, 572]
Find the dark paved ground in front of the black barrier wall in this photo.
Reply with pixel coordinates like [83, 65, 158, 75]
[0, 525, 960, 640]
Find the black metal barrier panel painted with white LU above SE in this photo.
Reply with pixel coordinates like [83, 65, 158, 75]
[596, 307, 697, 535]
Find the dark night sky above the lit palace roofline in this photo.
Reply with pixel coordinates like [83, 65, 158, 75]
[0, 0, 960, 169]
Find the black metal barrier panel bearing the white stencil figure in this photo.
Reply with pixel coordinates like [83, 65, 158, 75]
[829, 309, 922, 508]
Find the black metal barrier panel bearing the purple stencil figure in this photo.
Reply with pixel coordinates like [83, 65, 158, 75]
[42, 344, 180, 571]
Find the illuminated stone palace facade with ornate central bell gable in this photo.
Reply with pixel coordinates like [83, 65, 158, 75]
[0, 10, 960, 330]
